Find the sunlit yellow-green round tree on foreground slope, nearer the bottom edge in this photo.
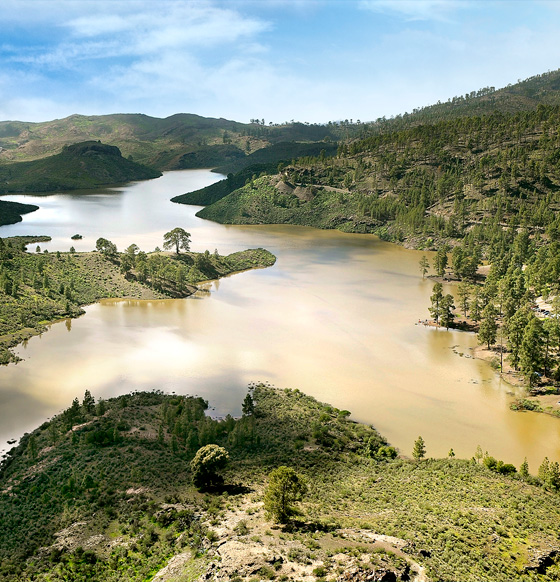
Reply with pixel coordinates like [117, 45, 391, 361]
[264, 466, 307, 523]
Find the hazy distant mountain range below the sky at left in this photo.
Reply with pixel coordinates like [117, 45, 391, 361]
[0, 113, 340, 170]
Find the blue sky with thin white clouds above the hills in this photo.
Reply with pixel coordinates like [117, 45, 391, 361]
[0, 0, 560, 123]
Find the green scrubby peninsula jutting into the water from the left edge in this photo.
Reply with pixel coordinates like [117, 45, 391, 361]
[0, 237, 275, 364]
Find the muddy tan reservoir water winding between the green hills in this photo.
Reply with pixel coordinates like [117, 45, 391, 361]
[0, 170, 560, 473]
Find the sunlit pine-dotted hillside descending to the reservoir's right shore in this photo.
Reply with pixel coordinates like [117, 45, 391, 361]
[199, 105, 560, 248]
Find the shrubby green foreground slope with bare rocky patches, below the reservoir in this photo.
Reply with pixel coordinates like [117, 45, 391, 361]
[0, 385, 560, 582]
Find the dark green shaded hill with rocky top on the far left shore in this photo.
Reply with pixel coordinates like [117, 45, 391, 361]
[0, 141, 161, 194]
